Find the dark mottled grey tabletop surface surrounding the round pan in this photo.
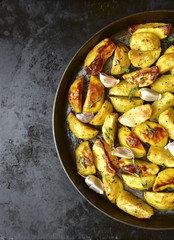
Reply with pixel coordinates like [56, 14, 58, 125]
[0, 0, 174, 240]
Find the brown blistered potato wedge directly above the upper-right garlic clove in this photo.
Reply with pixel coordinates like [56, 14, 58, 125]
[123, 66, 159, 87]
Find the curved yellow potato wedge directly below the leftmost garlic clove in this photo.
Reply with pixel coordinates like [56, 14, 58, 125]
[67, 112, 99, 140]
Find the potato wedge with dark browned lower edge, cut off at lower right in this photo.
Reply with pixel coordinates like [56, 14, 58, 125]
[153, 168, 174, 192]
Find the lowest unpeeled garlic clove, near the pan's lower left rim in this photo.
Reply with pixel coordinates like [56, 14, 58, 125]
[85, 175, 104, 194]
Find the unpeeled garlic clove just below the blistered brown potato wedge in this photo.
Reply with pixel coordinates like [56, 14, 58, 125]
[139, 88, 162, 102]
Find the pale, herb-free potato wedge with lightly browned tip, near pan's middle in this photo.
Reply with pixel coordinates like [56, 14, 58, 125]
[118, 104, 152, 127]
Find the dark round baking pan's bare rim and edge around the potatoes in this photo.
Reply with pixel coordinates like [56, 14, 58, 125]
[53, 10, 174, 230]
